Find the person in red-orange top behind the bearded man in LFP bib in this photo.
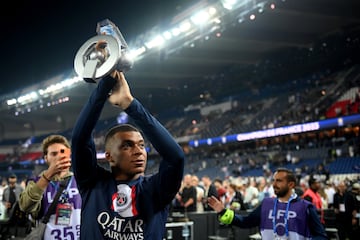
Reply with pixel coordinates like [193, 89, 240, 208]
[302, 175, 325, 224]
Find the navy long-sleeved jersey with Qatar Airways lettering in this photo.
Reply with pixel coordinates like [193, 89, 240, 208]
[72, 77, 184, 240]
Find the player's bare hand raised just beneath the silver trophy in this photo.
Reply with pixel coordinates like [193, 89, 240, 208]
[109, 70, 134, 110]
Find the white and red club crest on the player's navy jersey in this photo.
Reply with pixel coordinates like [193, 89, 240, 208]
[111, 184, 137, 217]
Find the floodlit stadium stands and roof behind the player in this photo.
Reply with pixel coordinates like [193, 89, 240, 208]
[0, 0, 360, 240]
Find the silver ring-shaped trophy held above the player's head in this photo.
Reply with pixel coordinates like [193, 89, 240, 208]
[74, 19, 133, 83]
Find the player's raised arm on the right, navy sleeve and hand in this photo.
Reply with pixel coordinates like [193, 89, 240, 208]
[109, 72, 185, 204]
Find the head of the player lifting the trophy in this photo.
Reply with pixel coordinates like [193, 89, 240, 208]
[106, 131, 147, 180]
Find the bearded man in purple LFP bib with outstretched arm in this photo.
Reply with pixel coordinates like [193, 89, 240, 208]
[208, 168, 328, 240]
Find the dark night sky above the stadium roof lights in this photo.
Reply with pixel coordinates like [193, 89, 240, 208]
[0, 0, 197, 94]
